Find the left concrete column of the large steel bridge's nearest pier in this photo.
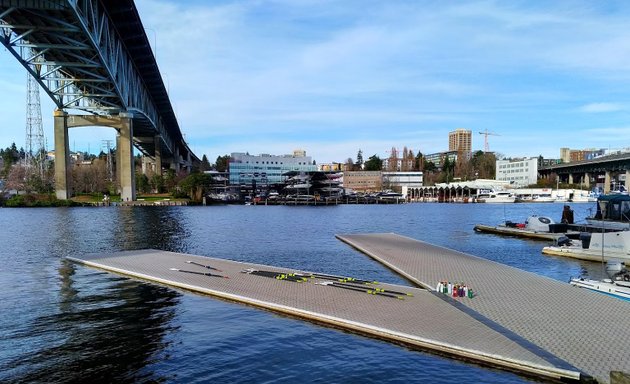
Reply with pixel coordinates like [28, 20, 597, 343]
[53, 109, 72, 200]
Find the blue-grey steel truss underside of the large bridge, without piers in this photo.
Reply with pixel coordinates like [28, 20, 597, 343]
[0, 0, 179, 156]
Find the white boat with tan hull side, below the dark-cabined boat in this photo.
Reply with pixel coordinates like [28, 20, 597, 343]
[542, 231, 630, 262]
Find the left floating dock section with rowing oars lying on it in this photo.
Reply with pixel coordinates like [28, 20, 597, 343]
[73, 249, 588, 381]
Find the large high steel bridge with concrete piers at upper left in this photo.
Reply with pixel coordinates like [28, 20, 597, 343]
[0, 0, 199, 200]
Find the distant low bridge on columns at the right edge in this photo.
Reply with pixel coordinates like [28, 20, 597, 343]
[538, 153, 630, 193]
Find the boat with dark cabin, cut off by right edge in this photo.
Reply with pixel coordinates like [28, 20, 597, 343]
[586, 193, 630, 231]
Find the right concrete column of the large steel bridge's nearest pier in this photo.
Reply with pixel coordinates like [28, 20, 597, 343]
[116, 113, 136, 201]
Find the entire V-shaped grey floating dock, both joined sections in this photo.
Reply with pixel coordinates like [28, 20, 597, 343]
[68, 234, 630, 382]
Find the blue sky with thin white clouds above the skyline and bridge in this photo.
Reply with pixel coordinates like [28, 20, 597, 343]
[0, 0, 630, 163]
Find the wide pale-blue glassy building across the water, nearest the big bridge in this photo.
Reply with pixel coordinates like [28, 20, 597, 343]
[228, 150, 317, 185]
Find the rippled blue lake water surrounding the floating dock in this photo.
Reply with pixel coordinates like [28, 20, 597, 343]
[0, 204, 601, 383]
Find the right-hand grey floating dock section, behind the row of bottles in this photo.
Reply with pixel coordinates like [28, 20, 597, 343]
[337, 234, 630, 382]
